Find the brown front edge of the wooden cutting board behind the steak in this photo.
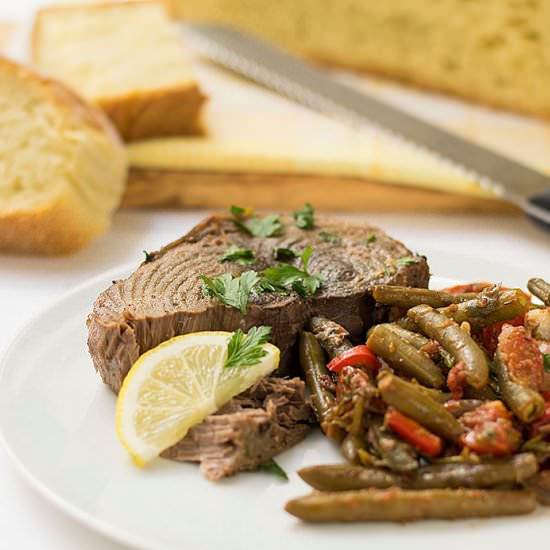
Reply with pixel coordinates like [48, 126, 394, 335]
[122, 168, 520, 213]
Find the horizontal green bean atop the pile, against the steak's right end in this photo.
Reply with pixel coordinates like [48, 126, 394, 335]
[372, 285, 477, 309]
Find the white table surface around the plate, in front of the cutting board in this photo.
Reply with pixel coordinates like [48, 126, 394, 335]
[0, 209, 550, 550]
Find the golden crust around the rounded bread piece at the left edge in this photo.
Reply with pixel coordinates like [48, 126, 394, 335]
[0, 57, 127, 255]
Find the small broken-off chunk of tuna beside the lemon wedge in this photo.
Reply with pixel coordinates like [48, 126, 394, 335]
[162, 378, 313, 480]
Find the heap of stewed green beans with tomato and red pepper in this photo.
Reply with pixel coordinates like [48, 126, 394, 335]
[286, 279, 550, 522]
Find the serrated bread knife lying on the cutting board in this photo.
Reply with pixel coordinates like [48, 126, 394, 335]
[181, 23, 550, 227]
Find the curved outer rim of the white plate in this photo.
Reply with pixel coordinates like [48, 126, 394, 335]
[0, 268, 459, 550]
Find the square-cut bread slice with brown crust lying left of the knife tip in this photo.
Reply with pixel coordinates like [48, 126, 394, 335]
[32, 0, 209, 141]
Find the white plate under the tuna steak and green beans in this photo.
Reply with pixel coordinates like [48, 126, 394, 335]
[0, 268, 550, 550]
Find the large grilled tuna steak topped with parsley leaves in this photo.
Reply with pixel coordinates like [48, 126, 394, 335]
[88, 212, 429, 392]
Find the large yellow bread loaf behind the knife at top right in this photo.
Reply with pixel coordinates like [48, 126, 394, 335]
[170, 0, 550, 117]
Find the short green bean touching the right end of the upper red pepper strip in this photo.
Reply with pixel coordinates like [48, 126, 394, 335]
[367, 324, 445, 388]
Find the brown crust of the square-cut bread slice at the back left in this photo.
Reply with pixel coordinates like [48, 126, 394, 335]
[31, 0, 208, 141]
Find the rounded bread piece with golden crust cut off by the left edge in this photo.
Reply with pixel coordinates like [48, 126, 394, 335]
[0, 58, 127, 254]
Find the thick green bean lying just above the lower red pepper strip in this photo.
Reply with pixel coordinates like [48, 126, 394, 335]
[378, 373, 462, 442]
